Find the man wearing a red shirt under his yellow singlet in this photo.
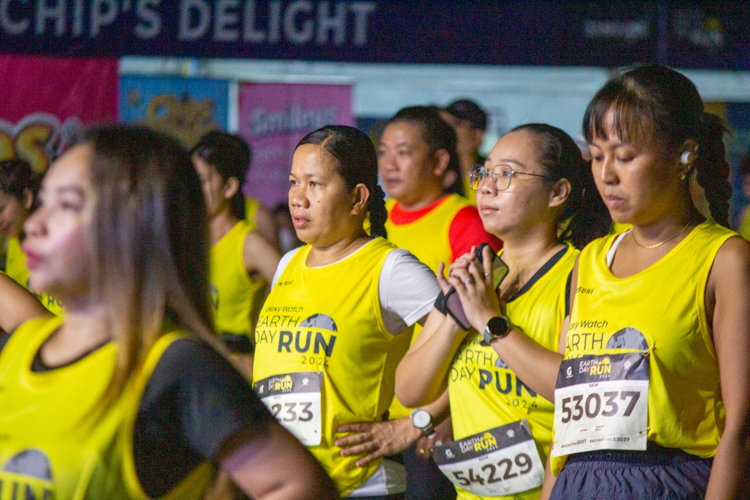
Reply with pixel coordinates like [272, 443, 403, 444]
[378, 106, 502, 499]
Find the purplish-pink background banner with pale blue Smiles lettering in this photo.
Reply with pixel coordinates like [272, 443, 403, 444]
[239, 83, 354, 208]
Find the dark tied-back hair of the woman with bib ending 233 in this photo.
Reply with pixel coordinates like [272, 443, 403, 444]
[297, 125, 388, 238]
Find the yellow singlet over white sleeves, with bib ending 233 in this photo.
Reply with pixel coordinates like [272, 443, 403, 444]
[253, 238, 411, 497]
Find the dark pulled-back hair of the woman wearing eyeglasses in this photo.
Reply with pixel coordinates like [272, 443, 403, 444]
[511, 123, 612, 248]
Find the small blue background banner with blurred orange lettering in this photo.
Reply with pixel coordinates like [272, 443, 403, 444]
[119, 75, 229, 148]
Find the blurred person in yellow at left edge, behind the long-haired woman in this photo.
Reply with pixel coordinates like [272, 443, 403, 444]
[0, 158, 63, 315]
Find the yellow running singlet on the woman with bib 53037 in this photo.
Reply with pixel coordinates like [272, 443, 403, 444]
[552, 222, 736, 474]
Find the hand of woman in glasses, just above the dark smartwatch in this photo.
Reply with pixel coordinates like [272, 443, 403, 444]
[448, 243, 501, 332]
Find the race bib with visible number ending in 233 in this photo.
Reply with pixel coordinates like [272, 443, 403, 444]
[253, 372, 323, 446]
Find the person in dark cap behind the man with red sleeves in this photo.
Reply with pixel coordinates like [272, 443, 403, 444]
[440, 99, 494, 205]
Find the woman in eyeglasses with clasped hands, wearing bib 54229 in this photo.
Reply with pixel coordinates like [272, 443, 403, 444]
[396, 124, 610, 499]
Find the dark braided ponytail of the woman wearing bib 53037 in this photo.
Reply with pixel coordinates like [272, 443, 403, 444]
[695, 113, 732, 227]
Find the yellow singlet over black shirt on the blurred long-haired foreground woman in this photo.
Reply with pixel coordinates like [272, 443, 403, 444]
[0, 318, 214, 500]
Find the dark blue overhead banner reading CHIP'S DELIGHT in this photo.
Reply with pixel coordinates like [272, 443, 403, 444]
[0, 0, 750, 69]
